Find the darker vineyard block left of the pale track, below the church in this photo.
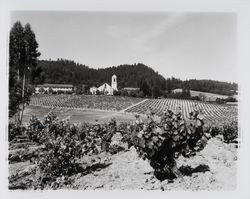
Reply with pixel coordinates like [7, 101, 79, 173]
[30, 95, 143, 111]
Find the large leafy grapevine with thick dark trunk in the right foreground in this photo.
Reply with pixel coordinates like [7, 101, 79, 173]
[127, 110, 204, 180]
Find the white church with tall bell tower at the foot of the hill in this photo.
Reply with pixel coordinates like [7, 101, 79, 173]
[90, 75, 117, 95]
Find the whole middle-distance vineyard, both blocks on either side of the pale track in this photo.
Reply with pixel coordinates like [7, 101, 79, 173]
[30, 95, 237, 123]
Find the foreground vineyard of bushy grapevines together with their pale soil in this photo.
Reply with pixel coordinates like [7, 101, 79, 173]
[8, 110, 238, 190]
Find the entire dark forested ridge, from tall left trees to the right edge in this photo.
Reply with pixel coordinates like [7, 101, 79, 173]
[33, 59, 237, 95]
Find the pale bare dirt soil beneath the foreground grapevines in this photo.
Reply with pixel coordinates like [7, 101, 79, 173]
[9, 135, 237, 191]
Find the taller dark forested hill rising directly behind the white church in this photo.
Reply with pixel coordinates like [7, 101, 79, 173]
[36, 60, 166, 90]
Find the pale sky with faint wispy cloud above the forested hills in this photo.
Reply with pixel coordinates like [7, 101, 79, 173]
[10, 11, 238, 82]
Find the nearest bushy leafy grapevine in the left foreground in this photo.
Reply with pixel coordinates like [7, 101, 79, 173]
[38, 122, 81, 181]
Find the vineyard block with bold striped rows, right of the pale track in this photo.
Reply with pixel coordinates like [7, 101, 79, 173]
[125, 99, 237, 123]
